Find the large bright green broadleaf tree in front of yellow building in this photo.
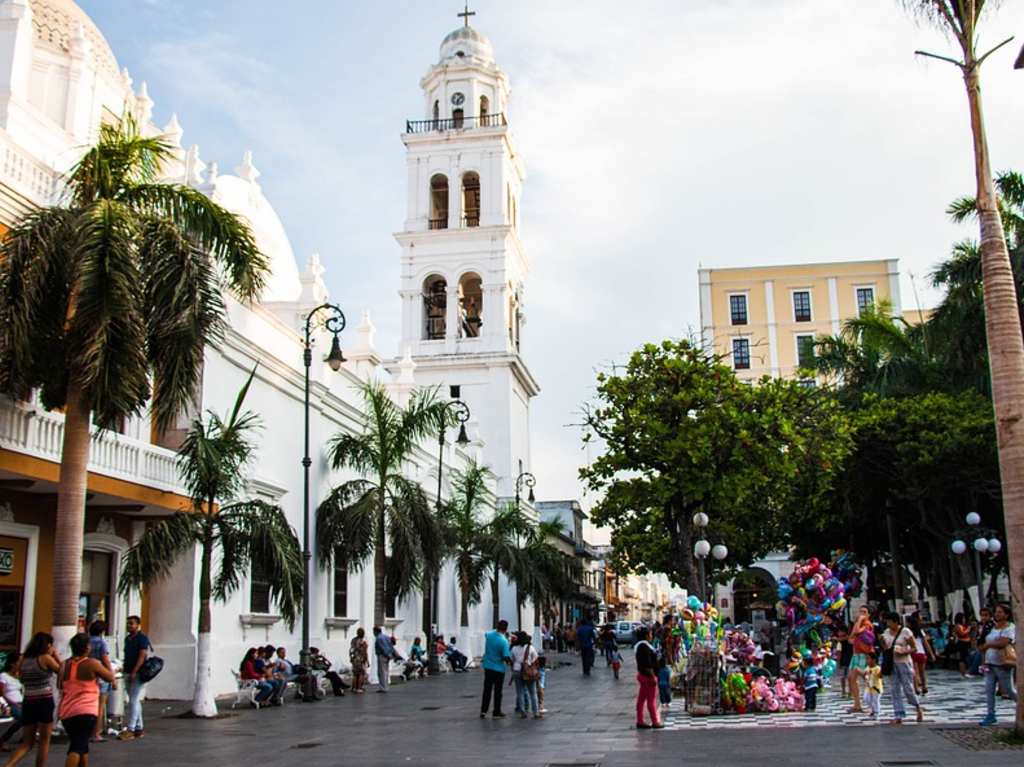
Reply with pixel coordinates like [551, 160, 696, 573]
[581, 341, 849, 593]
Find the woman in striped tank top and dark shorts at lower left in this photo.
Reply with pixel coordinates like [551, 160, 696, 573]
[4, 631, 60, 767]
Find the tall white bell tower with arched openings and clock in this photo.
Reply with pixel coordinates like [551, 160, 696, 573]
[395, 9, 540, 497]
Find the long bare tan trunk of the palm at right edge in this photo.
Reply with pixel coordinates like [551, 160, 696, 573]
[964, 62, 1024, 735]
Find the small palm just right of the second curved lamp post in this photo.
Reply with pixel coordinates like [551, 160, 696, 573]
[442, 462, 494, 629]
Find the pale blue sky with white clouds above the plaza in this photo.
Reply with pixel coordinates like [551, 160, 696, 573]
[79, 0, 1024, 538]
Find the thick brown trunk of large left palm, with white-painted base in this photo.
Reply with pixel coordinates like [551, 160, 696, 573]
[53, 384, 92, 653]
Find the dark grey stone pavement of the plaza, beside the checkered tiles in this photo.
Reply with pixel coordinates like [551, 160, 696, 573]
[49, 652, 1024, 767]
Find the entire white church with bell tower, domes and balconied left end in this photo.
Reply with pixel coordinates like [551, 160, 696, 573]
[0, 0, 539, 698]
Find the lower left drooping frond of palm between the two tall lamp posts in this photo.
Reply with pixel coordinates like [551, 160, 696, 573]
[316, 479, 380, 570]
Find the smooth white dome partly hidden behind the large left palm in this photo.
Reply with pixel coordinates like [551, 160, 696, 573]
[206, 175, 302, 303]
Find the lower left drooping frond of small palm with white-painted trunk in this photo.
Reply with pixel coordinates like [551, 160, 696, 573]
[118, 512, 203, 596]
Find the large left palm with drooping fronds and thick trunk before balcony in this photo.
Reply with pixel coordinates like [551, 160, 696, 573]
[0, 119, 267, 641]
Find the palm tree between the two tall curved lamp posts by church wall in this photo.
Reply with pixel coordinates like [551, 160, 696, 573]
[316, 381, 452, 626]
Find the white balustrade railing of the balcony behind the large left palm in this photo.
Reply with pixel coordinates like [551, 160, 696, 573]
[0, 397, 187, 495]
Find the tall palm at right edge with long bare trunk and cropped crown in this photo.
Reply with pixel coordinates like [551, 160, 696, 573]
[903, 0, 1024, 735]
